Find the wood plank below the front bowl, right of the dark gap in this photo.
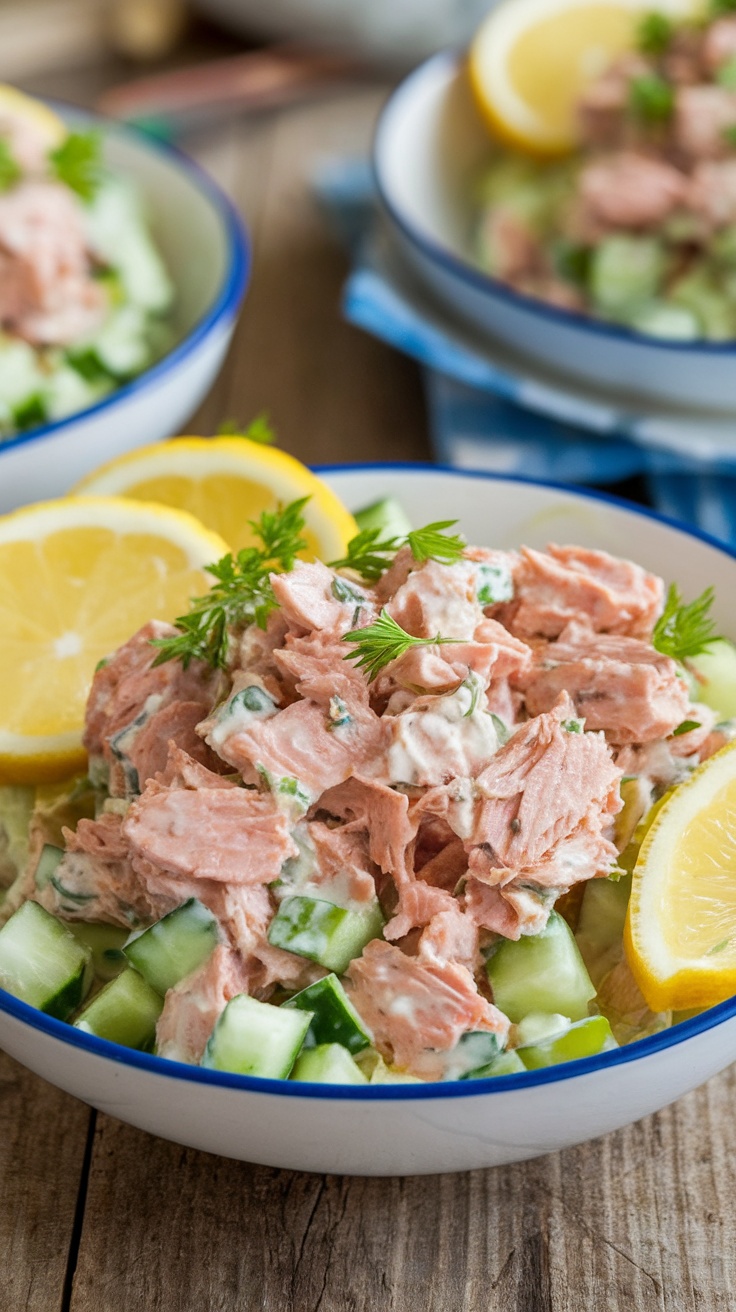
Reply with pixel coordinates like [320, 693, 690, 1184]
[64, 1072, 736, 1312]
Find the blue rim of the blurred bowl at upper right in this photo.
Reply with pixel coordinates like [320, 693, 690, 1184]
[371, 50, 736, 358]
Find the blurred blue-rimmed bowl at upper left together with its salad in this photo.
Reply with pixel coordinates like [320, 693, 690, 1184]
[0, 88, 249, 510]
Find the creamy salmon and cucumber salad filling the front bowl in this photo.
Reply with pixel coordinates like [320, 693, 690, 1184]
[0, 504, 733, 1084]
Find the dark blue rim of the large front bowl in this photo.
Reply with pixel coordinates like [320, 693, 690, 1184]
[0, 461, 736, 1102]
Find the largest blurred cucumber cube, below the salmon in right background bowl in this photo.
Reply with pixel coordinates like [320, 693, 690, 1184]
[589, 235, 666, 316]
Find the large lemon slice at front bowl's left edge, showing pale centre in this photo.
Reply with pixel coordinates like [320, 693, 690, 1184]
[0, 497, 227, 783]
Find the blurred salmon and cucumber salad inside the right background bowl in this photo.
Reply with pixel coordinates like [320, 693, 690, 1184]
[475, 5, 736, 341]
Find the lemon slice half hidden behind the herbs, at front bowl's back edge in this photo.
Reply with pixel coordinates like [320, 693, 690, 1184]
[73, 437, 358, 560]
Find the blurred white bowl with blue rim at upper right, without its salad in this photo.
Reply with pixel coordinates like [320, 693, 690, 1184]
[373, 52, 736, 411]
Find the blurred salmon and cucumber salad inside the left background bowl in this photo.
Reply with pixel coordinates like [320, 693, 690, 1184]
[0, 87, 173, 441]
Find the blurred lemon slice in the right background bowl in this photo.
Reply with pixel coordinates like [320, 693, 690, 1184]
[470, 0, 690, 155]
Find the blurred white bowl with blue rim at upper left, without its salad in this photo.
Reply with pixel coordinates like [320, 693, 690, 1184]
[0, 108, 249, 512]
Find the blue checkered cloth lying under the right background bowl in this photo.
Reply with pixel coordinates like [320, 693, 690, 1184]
[315, 160, 736, 543]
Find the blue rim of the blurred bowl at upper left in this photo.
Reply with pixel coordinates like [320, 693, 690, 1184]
[0, 100, 252, 461]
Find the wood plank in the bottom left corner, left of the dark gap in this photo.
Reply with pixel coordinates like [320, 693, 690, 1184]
[0, 1054, 91, 1312]
